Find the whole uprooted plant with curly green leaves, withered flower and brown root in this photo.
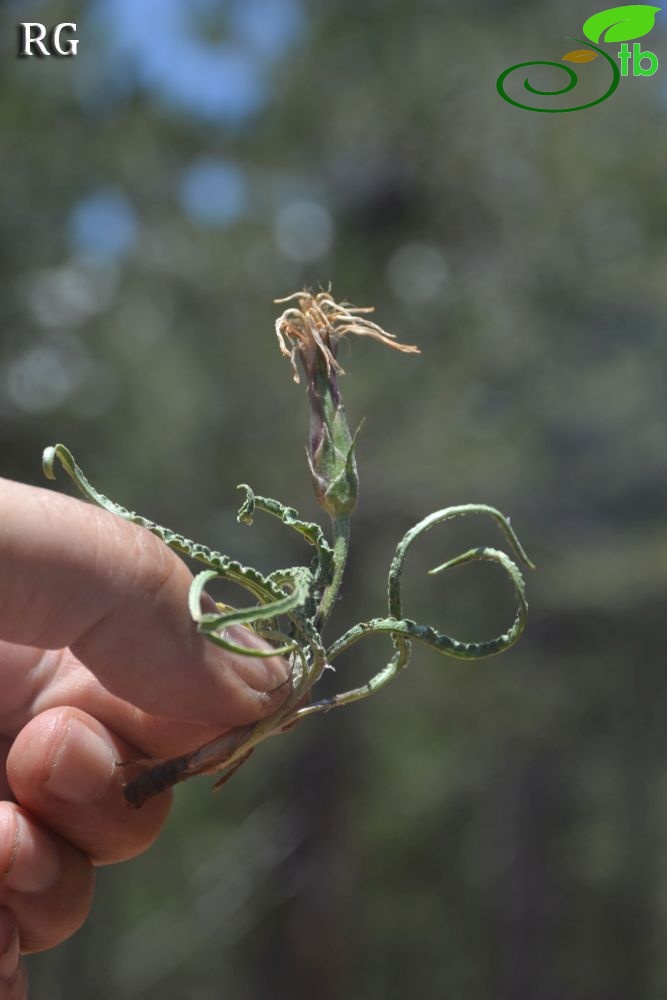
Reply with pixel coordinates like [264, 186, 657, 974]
[43, 290, 532, 807]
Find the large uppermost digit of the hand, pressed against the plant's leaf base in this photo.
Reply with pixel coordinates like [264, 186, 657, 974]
[0, 479, 289, 726]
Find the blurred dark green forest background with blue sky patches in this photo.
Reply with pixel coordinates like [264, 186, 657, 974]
[0, 0, 667, 1000]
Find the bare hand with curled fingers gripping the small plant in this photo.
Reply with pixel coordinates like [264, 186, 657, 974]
[0, 479, 289, 1000]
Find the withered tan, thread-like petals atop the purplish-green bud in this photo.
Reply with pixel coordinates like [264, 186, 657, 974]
[274, 289, 420, 382]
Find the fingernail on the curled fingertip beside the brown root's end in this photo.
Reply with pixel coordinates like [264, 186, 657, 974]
[45, 719, 114, 806]
